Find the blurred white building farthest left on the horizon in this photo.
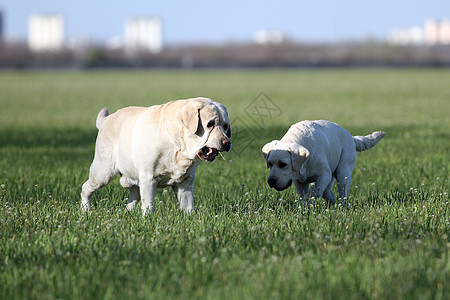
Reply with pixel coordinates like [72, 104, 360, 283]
[28, 14, 65, 51]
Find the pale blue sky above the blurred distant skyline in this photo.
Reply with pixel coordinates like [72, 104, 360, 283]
[0, 0, 450, 43]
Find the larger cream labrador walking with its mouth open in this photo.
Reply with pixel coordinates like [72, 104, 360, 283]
[81, 98, 231, 215]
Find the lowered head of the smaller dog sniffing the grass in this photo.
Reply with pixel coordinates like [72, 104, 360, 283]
[262, 140, 309, 191]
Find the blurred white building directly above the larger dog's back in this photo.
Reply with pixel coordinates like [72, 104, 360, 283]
[124, 17, 163, 53]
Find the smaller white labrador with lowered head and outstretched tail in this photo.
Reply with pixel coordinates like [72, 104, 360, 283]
[262, 120, 385, 203]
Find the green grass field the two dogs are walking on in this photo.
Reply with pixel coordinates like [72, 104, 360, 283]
[0, 69, 450, 299]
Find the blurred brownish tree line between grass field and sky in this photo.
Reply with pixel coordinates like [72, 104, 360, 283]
[0, 41, 450, 69]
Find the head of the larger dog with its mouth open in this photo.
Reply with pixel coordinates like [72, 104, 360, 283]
[180, 98, 231, 162]
